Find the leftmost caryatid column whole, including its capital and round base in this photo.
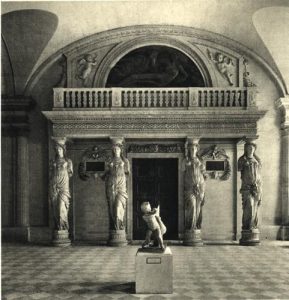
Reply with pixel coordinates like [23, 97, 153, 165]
[48, 137, 73, 247]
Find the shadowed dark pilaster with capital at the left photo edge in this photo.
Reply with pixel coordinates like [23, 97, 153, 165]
[2, 96, 33, 242]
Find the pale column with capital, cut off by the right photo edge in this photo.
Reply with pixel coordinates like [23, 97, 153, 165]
[276, 95, 289, 240]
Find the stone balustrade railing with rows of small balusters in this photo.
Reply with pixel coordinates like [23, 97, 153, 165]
[54, 88, 256, 109]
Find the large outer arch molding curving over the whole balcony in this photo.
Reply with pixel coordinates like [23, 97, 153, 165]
[25, 25, 286, 95]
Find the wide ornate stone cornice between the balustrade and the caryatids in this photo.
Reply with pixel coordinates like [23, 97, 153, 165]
[43, 110, 265, 138]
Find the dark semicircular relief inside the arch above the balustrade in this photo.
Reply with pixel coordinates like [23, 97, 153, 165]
[106, 46, 205, 87]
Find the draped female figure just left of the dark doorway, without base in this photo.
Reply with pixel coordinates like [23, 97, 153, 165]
[105, 143, 130, 230]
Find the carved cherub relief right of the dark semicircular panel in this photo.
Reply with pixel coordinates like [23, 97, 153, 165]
[207, 49, 236, 86]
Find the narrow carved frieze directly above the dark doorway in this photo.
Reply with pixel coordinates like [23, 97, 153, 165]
[128, 144, 183, 153]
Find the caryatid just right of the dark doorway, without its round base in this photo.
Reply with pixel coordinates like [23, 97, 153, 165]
[183, 139, 205, 244]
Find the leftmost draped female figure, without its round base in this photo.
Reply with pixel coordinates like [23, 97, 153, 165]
[49, 143, 73, 230]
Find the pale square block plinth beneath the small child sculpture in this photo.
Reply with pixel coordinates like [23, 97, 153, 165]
[135, 247, 173, 294]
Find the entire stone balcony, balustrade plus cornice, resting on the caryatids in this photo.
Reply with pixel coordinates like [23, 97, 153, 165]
[43, 87, 265, 138]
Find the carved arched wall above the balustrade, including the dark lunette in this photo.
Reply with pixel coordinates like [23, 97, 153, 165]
[59, 26, 260, 87]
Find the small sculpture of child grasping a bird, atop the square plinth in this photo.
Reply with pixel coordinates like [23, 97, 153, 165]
[141, 202, 167, 251]
